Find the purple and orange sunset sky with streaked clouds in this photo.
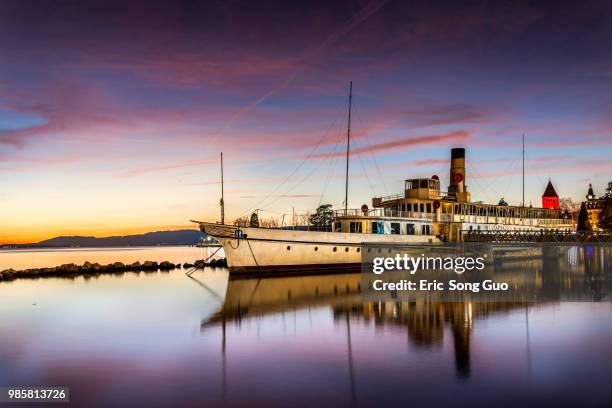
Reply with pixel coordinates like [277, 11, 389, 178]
[0, 0, 612, 243]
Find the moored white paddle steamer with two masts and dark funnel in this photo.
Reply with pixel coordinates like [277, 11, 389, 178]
[196, 85, 572, 273]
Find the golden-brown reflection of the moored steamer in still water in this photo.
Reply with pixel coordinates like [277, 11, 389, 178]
[202, 273, 488, 377]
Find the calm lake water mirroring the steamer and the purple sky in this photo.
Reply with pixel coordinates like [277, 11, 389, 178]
[0, 248, 612, 407]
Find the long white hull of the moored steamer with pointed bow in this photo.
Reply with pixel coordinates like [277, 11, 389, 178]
[200, 222, 440, 274]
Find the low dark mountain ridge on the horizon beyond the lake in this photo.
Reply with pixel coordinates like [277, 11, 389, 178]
[33, 230, 204, 247]
